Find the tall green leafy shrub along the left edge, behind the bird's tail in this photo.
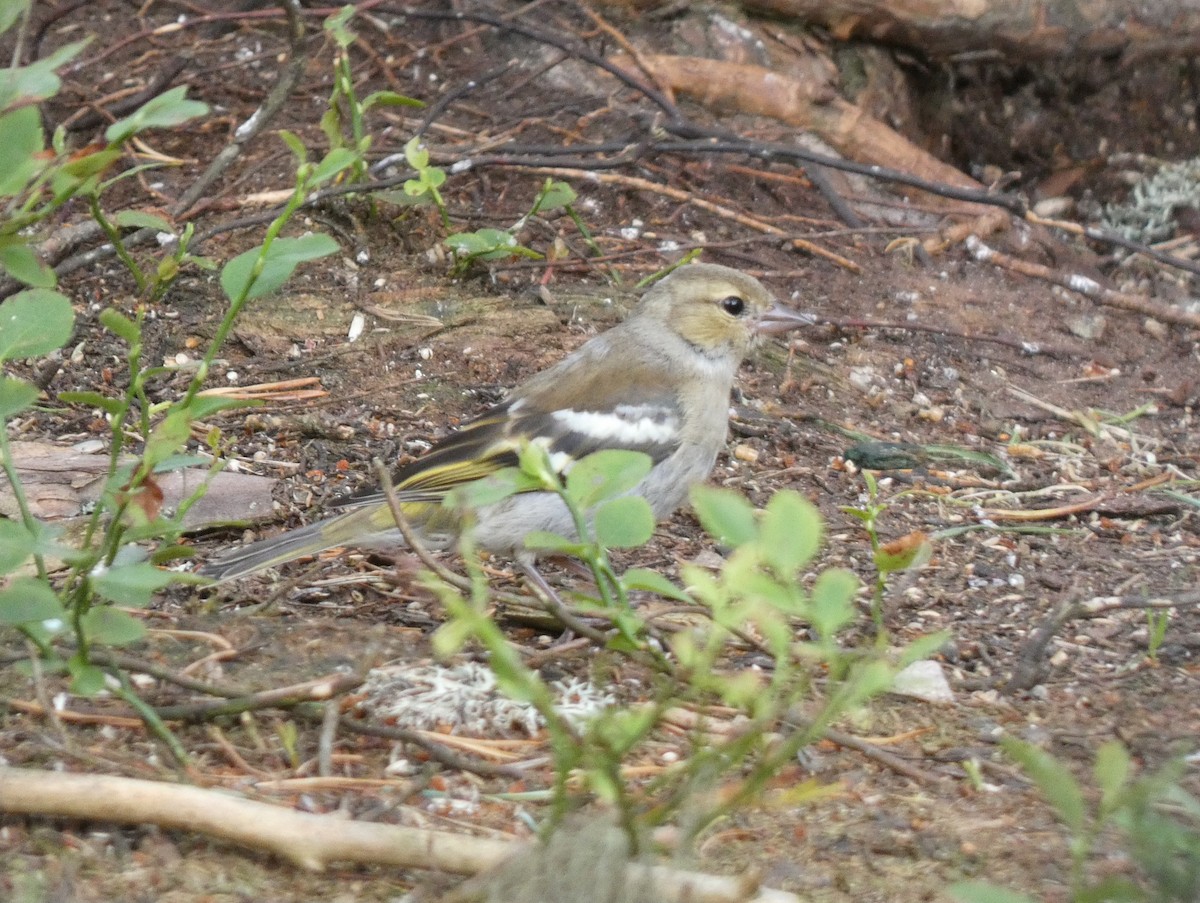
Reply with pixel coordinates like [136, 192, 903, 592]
[0, 10, 350, 734]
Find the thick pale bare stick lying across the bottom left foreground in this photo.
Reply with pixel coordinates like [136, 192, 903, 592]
[0, 767, 800, 903]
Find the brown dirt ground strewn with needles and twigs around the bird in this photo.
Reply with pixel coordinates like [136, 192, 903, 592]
[0, 2, 1200, 903]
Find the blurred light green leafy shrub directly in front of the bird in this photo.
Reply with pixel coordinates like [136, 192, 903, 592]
[426, 445, 944, 844]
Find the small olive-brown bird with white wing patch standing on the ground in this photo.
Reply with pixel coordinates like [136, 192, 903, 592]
[198, 263, 816, 582]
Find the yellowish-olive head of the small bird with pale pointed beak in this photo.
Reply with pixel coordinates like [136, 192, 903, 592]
[638, 263, 815, 359]
